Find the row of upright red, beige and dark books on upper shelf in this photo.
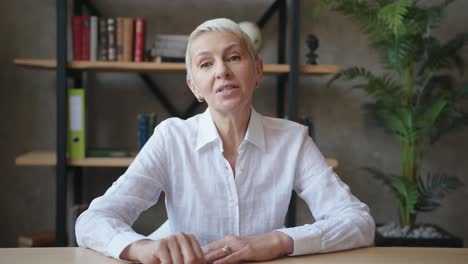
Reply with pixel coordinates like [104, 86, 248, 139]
[72, 16, 146, 62]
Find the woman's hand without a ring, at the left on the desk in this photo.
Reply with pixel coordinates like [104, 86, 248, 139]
[120, 233, 206, 264]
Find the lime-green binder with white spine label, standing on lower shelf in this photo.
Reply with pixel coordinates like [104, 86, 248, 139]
[68, 88, 86, 159]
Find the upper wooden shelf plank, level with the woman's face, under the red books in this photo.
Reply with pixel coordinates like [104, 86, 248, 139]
[14, 59, 338, 75]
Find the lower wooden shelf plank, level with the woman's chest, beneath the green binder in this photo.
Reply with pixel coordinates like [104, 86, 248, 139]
[15, 151, 338, 168]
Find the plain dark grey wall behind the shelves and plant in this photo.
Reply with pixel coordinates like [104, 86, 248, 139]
[0, 0, 468, 247]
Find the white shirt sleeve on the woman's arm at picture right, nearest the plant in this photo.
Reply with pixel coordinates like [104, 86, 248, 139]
[277, 130, 375, 255]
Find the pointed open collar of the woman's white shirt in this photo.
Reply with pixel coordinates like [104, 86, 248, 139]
[196, 107, 265, 151]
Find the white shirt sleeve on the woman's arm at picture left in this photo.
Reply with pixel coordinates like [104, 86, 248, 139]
[75, 124, 171, 259]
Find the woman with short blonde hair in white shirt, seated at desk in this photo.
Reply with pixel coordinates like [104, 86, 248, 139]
[76, 19, 374, 263]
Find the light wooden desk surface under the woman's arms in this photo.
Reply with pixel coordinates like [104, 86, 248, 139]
[0, 247, 468, 264]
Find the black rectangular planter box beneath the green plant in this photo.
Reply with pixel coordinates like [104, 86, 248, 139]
[375, 224, 463, 248]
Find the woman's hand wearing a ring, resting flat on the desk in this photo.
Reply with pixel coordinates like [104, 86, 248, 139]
[203, 231, 294, 264]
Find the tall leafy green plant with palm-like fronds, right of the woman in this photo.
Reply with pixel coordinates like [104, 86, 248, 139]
[320, 0, 468, 245]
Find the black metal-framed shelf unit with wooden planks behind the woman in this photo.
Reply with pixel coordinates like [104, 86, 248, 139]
[14, 0, 338, 246]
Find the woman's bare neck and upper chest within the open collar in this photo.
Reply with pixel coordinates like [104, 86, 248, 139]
[210, 105, 251, 155]
